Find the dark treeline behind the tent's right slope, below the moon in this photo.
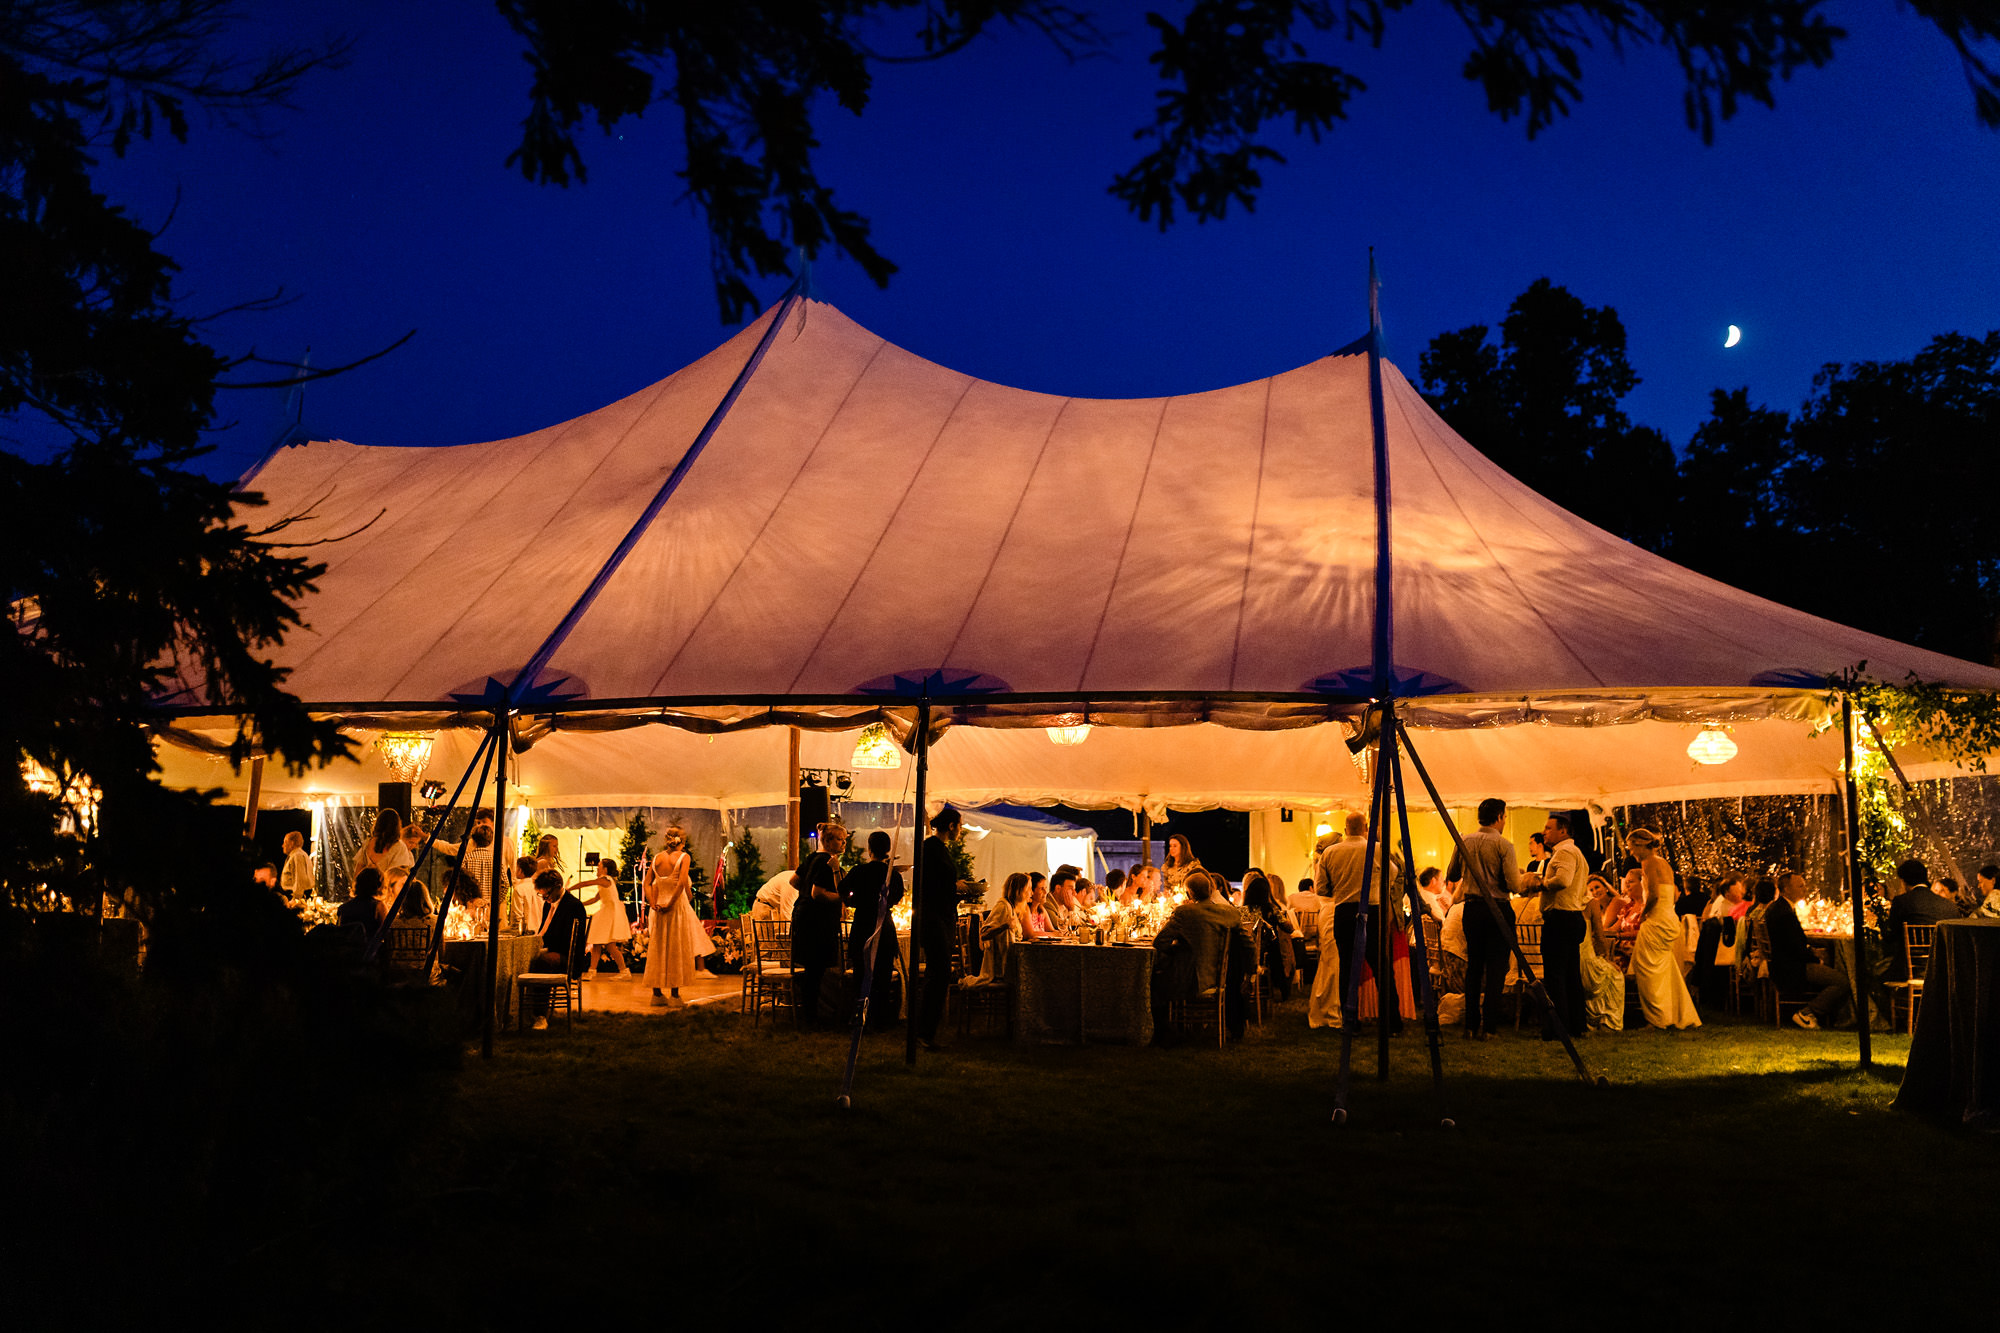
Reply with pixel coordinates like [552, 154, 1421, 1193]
[1418, 278, 2000, 662]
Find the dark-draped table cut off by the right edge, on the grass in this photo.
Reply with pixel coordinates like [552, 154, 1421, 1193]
[1896, 919, 2000, 1133]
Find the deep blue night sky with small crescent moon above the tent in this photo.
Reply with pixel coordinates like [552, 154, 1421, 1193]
[86, 0, 2000, 474]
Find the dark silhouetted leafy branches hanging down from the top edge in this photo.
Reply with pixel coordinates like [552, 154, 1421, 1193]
[496, 0, 2000, 322]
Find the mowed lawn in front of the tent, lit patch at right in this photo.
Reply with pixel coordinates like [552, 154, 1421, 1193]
[324, 1005, 2000, 1329]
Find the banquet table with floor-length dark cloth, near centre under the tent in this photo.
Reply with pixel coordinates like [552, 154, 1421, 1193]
[1010, 941, 1152, 1045]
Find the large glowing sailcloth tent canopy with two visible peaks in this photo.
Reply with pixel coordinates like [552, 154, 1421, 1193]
[160, 296, 2000, 813]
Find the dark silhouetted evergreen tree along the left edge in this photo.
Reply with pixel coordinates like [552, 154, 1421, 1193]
[0, 0, 346, 907]
